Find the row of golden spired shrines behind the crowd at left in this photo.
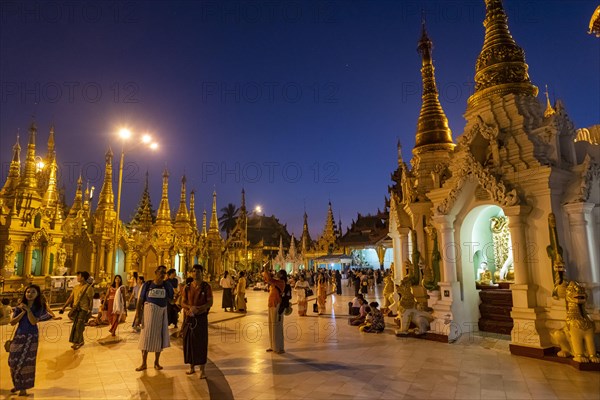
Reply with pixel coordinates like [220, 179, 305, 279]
[0, 129, 224, 291]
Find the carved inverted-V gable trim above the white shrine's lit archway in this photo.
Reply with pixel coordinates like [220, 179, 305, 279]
[437, 152, 519, 215]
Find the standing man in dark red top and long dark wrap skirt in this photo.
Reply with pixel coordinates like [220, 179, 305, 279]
[181, 264, 213, 379]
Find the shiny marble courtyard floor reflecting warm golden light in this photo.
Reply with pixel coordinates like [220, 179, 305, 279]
[0, 286, 600, 400]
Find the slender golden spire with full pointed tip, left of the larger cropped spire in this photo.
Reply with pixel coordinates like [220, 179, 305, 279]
[414, 20, 454, 155]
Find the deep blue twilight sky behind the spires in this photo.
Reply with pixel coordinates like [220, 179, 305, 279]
[0, 0, 600, 237]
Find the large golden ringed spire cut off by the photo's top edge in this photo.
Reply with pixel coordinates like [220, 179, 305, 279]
[467, 0, 538, 106]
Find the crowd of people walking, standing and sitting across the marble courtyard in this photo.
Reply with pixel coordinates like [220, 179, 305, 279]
[0, 265, 385, 396]
